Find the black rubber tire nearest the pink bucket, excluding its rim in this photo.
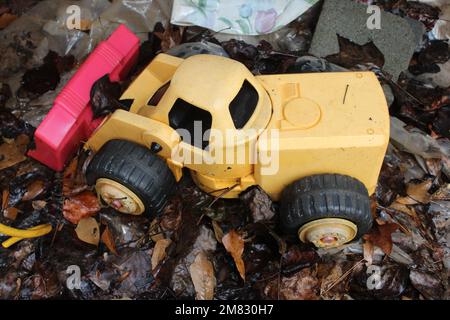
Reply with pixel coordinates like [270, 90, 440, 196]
[86, 140, 176, 218]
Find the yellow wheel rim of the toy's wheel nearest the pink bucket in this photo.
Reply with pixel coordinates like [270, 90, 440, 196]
[95, 178, 145, 215]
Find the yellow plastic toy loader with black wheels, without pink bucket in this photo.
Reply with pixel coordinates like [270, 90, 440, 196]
[85, 54, 389, 247]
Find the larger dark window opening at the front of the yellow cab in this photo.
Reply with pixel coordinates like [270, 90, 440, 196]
[169, 99, 212, 150]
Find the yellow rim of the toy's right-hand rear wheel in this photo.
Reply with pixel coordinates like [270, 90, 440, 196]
[298, 218, 358, 248]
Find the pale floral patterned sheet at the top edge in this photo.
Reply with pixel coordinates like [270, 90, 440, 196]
[172, 0, 319, 35]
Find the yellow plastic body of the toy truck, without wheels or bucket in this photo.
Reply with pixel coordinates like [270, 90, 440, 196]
[85, 54, 389, 200]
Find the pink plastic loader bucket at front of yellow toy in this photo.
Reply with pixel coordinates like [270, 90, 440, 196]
[28, 25, 140, 171]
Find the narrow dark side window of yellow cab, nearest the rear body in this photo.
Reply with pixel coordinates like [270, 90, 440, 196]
[230, 80, 259, 129]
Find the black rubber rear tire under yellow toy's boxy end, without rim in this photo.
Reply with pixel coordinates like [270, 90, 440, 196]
[280, 174, 373, 238]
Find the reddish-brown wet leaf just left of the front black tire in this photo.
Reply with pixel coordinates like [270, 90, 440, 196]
[63, 191, 100, 224]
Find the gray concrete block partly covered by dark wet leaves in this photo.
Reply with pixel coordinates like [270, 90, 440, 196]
[310, 0, 425, 80]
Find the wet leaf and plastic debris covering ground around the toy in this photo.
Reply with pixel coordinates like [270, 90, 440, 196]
[0, 0, 450, 300]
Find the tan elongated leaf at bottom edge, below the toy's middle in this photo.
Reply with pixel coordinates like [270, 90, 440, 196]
[189, 251, 216, 300]
